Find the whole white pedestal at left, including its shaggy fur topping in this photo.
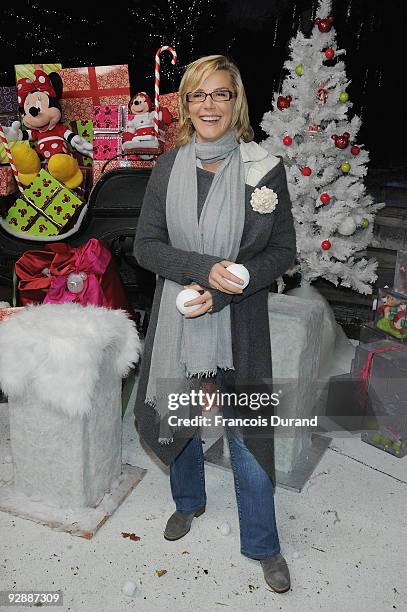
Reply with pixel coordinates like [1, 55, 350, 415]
[0, 304, 141, 516]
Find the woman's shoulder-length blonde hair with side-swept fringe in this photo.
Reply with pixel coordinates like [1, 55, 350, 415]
[177, 55, 254, 146]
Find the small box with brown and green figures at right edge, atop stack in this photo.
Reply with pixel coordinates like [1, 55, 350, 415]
[375, 289, 407, 341]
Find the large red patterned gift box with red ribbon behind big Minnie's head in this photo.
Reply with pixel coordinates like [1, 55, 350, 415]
[60, 64, 130, 121]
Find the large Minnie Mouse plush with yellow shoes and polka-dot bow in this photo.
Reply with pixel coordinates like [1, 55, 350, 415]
[3, 70, 93, 189]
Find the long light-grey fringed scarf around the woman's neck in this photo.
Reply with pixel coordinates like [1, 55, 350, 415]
[146, 130, 245, 443]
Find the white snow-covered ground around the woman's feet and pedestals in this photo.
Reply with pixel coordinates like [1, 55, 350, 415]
[0, 378, 407, 612]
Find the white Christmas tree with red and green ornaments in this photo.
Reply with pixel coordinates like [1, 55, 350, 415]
[261, 0, 384, 294]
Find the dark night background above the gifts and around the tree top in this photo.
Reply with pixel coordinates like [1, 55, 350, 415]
[0, 0, 407, 169]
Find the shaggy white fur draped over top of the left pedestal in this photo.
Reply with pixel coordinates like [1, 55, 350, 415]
[0, 303, 141, 416]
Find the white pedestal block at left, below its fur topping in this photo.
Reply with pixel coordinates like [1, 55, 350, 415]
[9, 351, 122, 508]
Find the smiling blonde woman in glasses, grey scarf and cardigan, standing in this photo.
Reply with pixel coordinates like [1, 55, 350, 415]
[134, 55, 296, 592]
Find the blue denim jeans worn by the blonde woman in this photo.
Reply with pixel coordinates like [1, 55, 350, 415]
[170, 370, 280, 559]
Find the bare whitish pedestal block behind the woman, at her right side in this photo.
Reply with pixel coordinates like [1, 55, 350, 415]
[268, 294, 323, 473]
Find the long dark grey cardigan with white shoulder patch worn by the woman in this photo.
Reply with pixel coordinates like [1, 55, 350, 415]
[134, 143, 296, 484]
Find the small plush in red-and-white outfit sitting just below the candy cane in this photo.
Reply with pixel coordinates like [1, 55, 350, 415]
[123, 91, 172, 152]
